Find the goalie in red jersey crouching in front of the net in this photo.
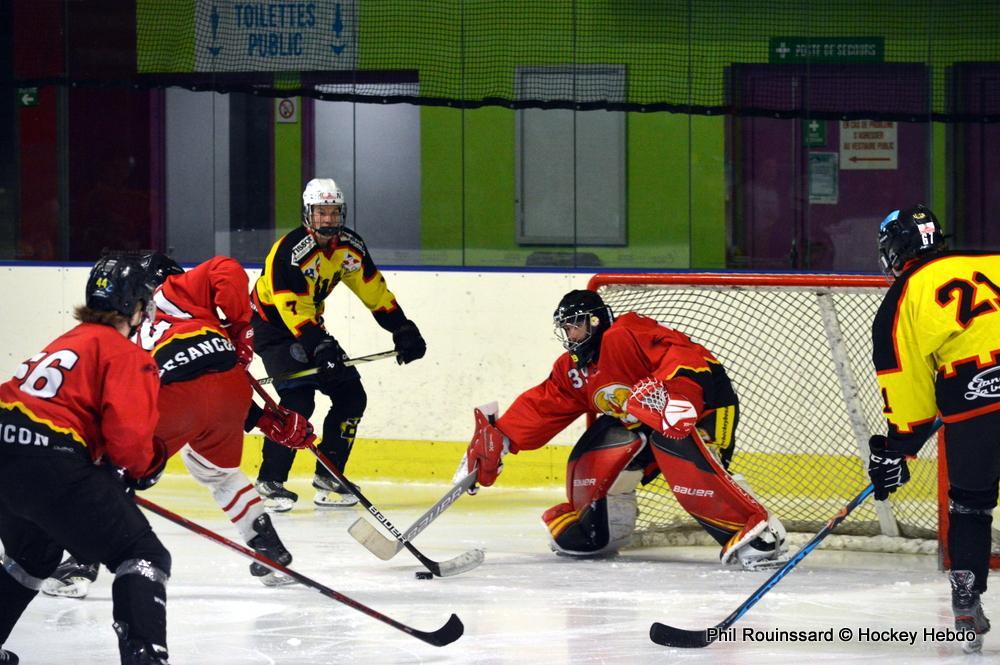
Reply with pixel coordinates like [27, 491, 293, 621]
[459, 290, 786, 568]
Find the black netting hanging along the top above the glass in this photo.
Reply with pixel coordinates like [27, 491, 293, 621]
[15, 0, 1000, 121]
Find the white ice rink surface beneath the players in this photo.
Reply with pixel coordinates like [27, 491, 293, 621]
[6, 476, 1000, 665]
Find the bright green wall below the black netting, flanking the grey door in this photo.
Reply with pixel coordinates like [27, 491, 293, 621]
[420, 107, 726, 268]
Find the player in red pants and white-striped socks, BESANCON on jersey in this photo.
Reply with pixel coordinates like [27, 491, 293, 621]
[42, 253, 312, 598]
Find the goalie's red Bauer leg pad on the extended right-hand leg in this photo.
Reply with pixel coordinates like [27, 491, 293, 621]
[651, 430, 784, 561]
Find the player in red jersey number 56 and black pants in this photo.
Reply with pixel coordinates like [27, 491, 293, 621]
[0, 257, 170, 665]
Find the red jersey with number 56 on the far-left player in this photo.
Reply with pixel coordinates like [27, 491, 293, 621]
[0, 323, 159, 478]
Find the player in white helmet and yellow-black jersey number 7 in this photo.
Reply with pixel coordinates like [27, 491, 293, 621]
[251, 178, 427, 512]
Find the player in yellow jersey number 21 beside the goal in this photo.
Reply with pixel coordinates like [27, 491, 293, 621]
[868, 205, 1000, 651]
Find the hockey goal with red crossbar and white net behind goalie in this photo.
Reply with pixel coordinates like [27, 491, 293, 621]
[590, 274, 998, 552]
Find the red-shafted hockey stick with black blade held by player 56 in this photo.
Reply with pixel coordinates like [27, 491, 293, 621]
[133, 496, 465, 647]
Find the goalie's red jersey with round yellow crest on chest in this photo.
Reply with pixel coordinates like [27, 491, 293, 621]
[497, 312, 736, 452]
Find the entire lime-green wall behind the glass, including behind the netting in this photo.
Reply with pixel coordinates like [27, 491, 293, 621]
[136, 0, 1000, 268]
